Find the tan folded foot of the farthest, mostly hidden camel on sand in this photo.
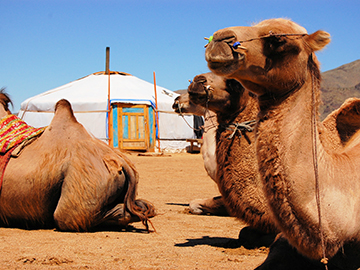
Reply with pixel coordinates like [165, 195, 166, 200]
[189, 196, 229, 216]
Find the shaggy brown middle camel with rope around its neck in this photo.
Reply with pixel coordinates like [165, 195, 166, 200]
[188, 73, 278, 246]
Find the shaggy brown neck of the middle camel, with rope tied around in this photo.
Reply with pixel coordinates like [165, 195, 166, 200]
[216, 93, 277, 232]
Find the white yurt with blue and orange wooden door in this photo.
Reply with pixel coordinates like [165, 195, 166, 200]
[19, 71, 194, 152]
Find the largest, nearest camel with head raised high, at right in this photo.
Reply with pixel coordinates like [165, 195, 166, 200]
[205, 19, 360, 269]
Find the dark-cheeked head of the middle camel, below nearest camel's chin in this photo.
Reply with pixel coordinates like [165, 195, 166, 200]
[188, 72, 252, 114]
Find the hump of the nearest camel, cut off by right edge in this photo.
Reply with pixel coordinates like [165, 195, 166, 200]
[324, 98, 360, 144]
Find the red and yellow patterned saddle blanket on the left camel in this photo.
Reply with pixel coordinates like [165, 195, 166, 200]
[0, 114, 45, 189]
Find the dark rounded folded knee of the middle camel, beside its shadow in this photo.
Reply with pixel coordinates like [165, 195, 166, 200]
[238, 227, 276, 249]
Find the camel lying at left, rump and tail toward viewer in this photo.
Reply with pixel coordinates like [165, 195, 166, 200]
[0, 91, 155, 231]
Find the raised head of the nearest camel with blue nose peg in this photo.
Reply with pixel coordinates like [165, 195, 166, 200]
[205, 19, 330, 96]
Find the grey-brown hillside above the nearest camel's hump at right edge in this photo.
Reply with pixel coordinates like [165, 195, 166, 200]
[320, 60, 360, 119]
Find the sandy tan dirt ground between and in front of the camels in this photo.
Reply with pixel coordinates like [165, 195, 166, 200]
[0, 153, 268, 270]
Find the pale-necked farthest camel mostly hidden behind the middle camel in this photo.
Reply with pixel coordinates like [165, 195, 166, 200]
[172, 92, 229, 216]
